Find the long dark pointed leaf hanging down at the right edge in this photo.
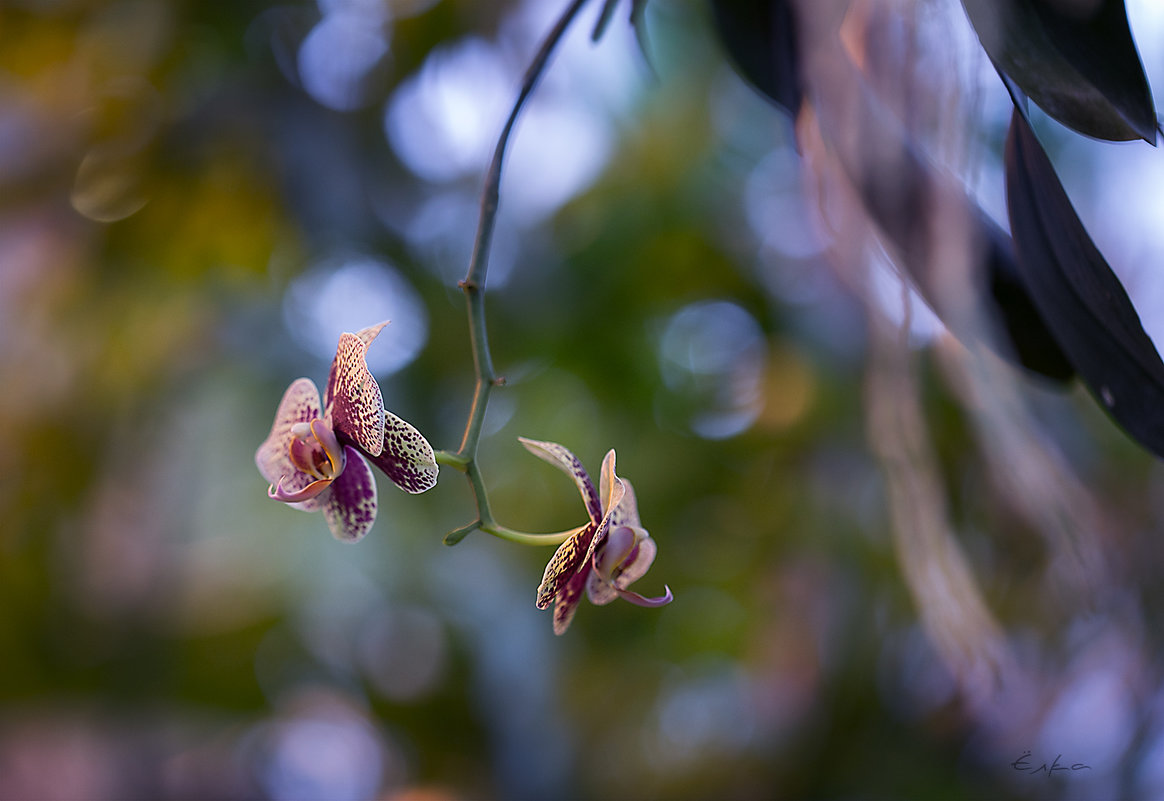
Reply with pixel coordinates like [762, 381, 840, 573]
[1006, 109, 1164, 456]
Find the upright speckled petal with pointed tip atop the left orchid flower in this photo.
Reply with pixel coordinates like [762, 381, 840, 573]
[324, 326, 384, 456]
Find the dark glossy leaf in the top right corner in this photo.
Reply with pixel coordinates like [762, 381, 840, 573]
[963, 0, 1156, 144]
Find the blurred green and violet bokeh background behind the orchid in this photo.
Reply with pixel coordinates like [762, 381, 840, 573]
[0, 0, 1164, 801]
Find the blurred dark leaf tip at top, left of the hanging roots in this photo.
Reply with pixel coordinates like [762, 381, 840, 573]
[711, 0, 803, 115]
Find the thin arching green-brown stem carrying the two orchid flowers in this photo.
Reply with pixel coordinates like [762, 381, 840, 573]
[438, 0, 587, 545]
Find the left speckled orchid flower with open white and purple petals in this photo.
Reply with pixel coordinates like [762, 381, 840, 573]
[255, 321, 438, 543]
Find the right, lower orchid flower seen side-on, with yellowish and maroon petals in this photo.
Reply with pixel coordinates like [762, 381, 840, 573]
[518, 438, 673, 635]
